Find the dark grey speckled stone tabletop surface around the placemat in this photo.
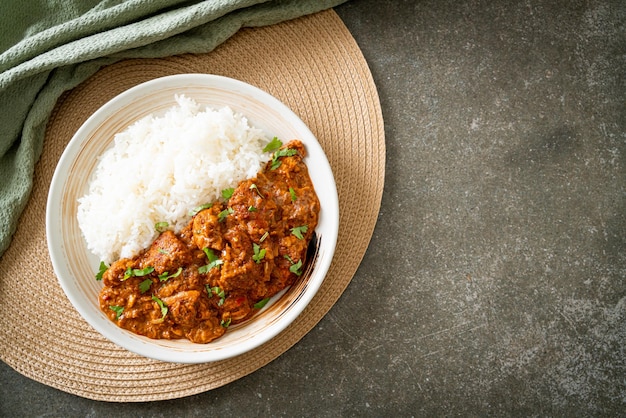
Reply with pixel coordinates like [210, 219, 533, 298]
[0, 0, 626, 417]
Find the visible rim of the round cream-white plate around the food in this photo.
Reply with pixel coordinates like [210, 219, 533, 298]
[46, 74, 339, 363]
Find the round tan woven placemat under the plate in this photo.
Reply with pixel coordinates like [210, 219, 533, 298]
[0, 10, 385, 402]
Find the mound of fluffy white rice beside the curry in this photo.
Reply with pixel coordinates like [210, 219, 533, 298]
[78, 96, 269, 263]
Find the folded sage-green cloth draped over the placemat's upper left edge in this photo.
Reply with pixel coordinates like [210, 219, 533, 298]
[0, 0, 345, 256]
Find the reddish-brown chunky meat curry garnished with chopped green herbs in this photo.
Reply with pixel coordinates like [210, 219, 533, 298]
[99, 140, 320, 343]
